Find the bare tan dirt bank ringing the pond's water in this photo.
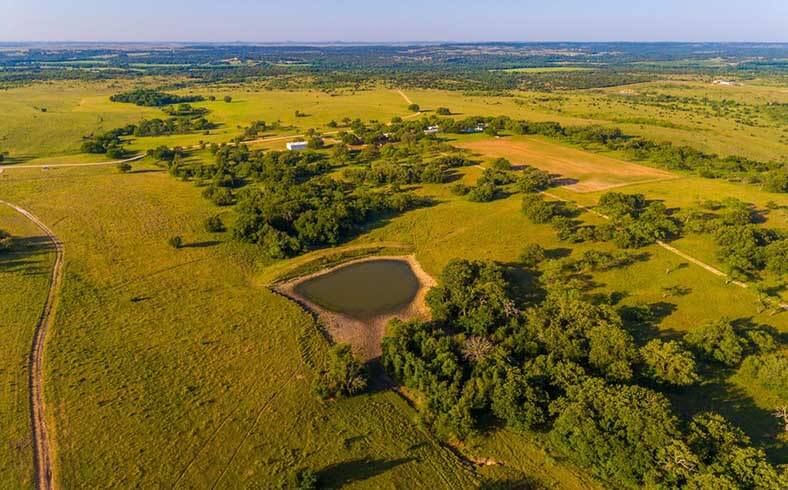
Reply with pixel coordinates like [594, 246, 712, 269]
[274, 255, 436, 360]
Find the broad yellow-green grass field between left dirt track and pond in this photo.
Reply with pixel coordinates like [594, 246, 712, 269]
[2, 165, 593, 488]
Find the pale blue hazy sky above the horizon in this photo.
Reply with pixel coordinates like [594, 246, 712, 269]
[0, 0, 788, 42]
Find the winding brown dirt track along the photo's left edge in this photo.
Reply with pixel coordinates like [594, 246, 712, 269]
[0, 200, 65, 490]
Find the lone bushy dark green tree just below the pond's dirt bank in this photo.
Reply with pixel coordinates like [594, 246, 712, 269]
[313, 344, 367, 399]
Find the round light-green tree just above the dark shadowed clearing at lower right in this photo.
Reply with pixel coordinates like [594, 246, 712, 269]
[640, 339, 700, 386]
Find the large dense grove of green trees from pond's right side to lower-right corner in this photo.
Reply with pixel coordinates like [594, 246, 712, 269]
[383, 258, 788, 489]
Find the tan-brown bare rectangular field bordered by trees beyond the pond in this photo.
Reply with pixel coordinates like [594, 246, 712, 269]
[457, 136, 676, 192]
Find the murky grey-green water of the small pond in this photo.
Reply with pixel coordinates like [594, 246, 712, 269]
[295, 259, 420, 320]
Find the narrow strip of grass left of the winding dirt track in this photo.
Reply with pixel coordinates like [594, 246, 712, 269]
[0, 204, 54, 488]
